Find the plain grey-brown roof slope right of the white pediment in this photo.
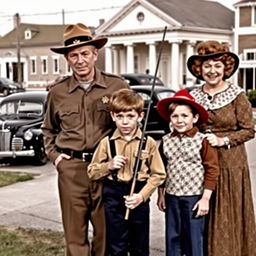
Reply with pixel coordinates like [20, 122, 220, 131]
[147, 0, 234, 29]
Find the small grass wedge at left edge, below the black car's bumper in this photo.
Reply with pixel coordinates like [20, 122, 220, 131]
[0, 171, 34, 187]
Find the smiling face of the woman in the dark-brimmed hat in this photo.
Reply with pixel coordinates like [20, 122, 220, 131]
[202, 60, 225, 86]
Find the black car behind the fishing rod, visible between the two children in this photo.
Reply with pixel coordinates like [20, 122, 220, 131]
[131, 85, 175, 136]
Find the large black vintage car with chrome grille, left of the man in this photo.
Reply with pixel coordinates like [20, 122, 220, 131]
[0, 91, 47, 165]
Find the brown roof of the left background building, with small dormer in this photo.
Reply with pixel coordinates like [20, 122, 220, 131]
[0, 23, 94, 48]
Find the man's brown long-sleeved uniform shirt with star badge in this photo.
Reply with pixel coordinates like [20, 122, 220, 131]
[42, 69, 129, 162]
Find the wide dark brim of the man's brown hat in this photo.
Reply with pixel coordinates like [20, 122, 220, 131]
[50, 38, 108, 54]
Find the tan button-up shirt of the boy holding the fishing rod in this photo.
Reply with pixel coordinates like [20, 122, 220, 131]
[88, 129, 166, 200]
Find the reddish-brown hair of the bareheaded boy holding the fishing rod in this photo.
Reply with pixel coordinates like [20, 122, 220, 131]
[110, 89, 144, 114]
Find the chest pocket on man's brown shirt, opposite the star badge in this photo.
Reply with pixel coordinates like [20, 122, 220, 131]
[59, 105, 81, 130]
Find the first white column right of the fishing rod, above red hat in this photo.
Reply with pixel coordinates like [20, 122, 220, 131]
[170, 41, 181, 91]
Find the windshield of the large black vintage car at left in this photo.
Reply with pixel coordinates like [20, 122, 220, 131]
[0, 100, 44, 116]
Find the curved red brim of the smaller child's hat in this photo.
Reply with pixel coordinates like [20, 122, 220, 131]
[157, 96, 208, 124]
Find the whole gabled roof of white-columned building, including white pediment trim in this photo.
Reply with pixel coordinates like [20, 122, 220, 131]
[97, 0, 234, 35]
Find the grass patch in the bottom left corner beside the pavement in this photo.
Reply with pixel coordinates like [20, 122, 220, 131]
[0, 226, 64, 256]
